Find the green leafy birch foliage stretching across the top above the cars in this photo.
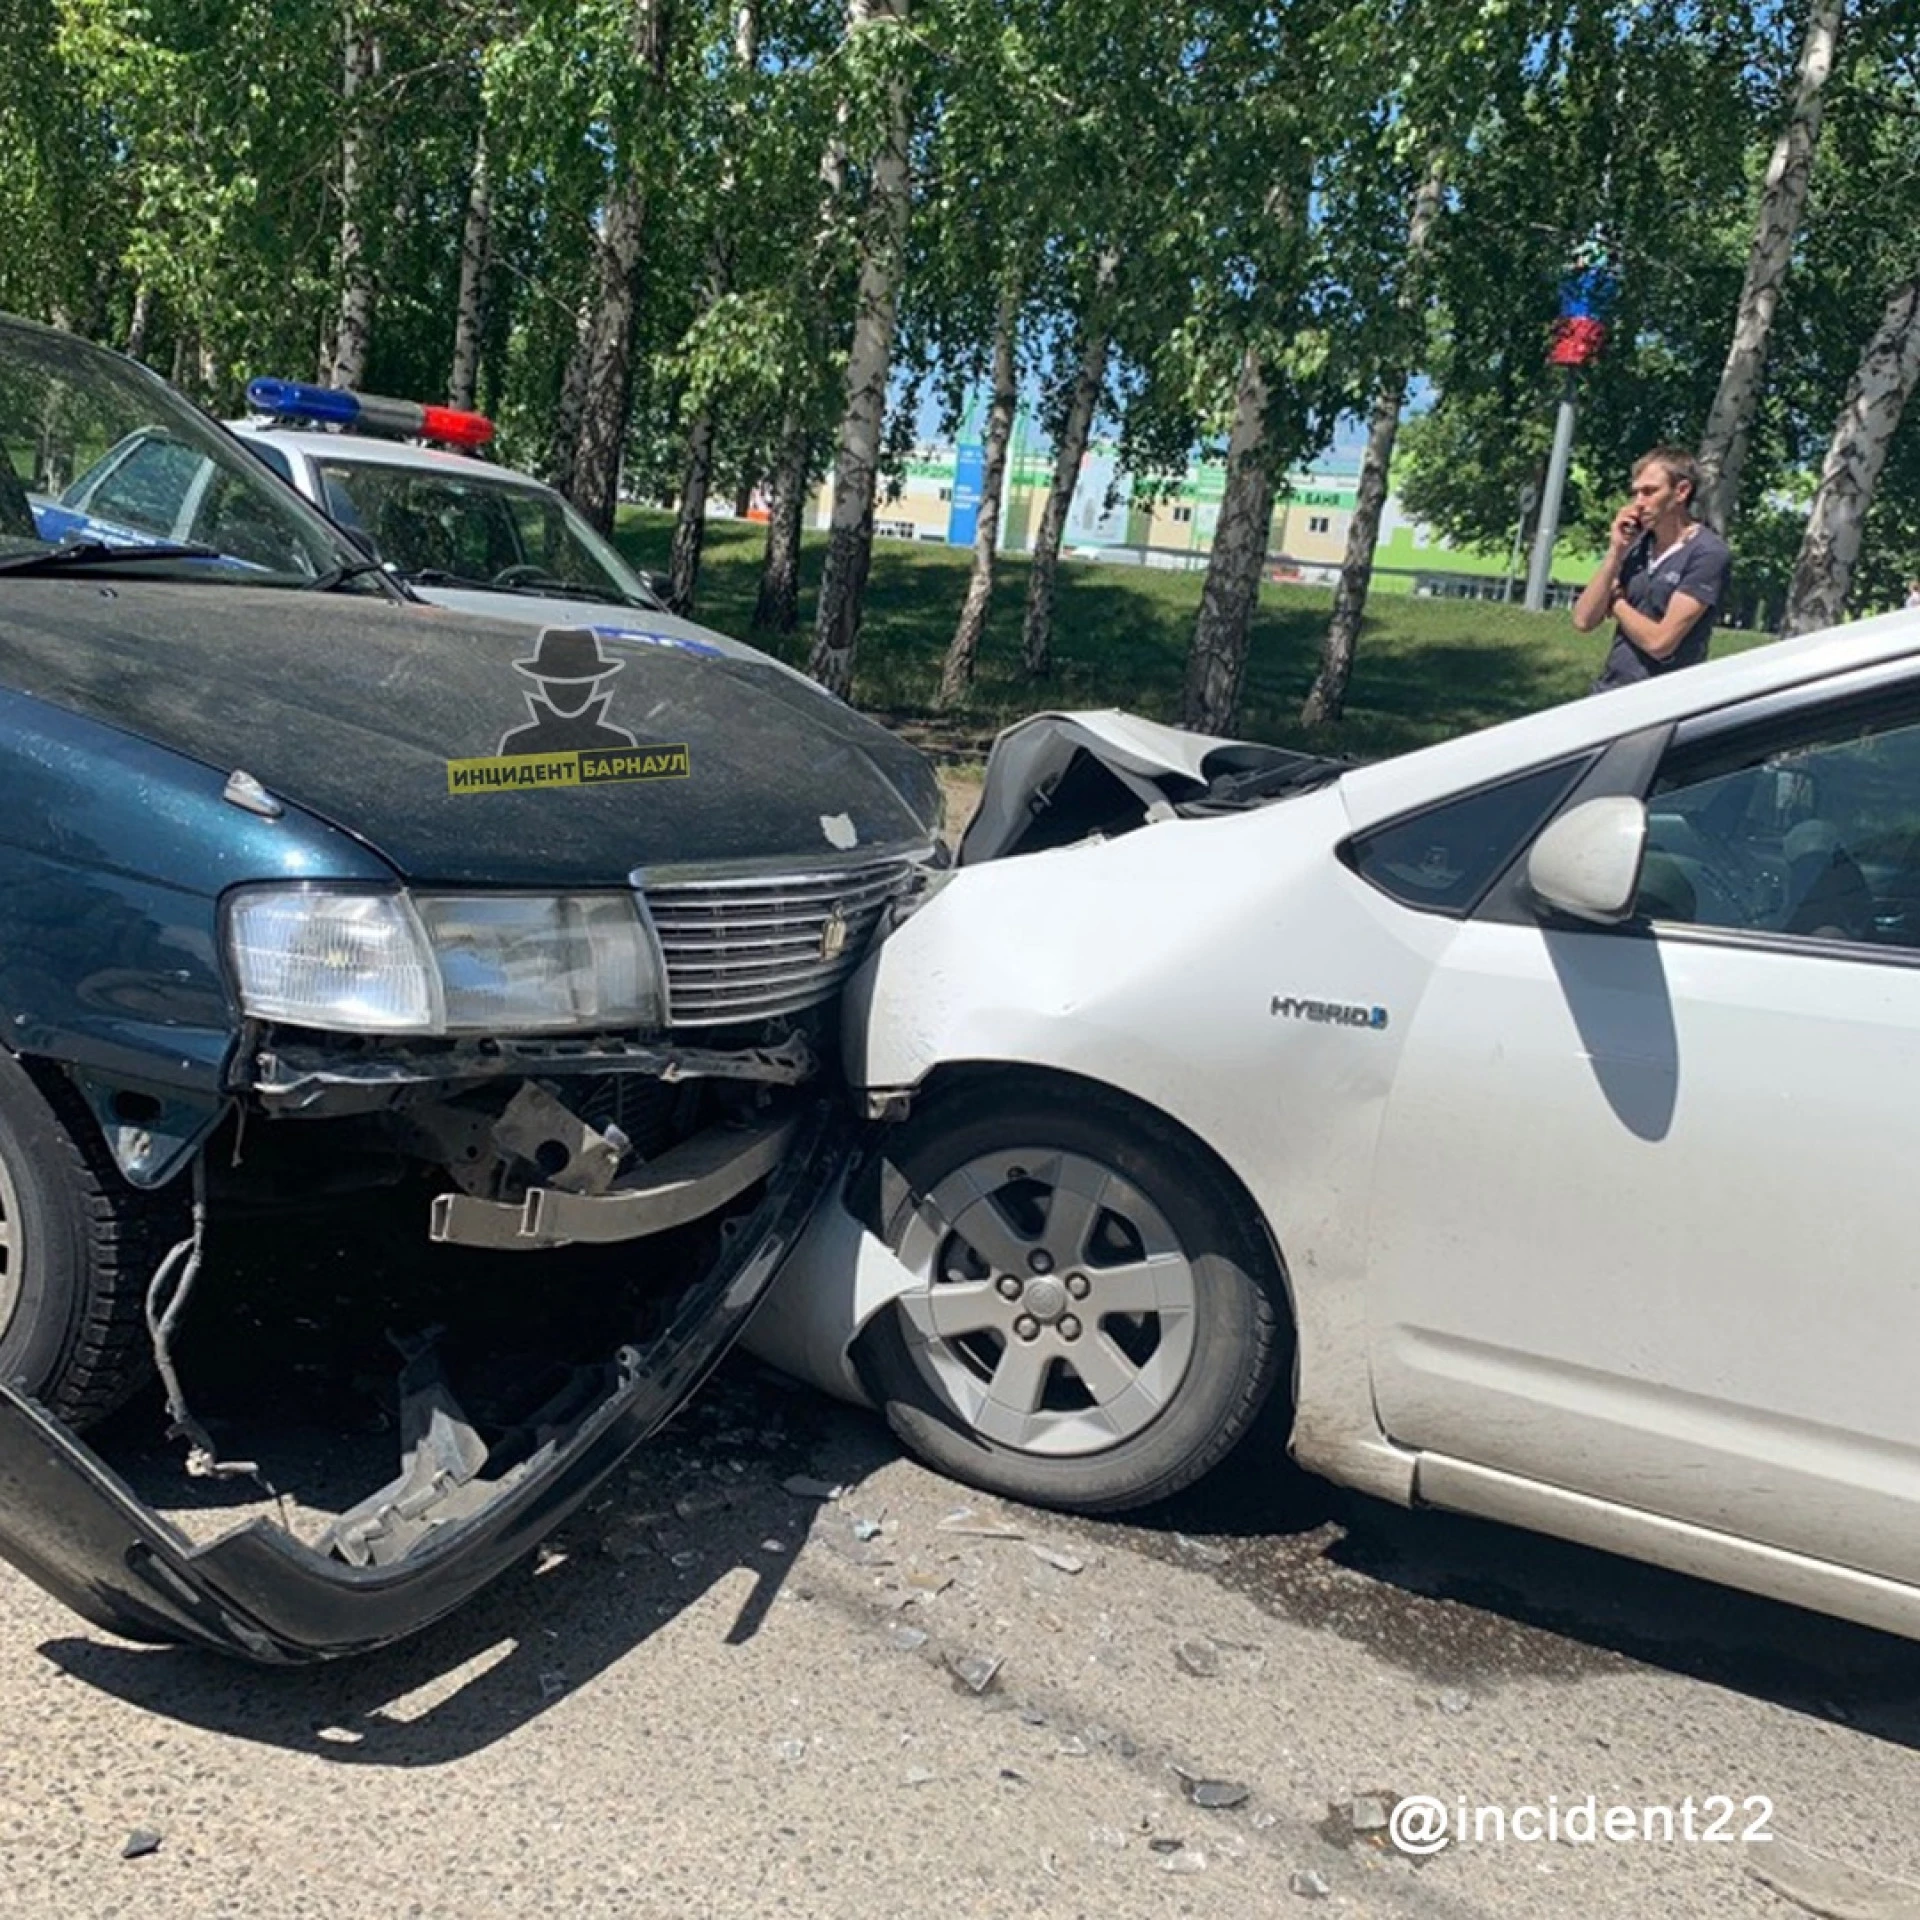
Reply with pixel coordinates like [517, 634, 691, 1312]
[11, 0, 1920, 629]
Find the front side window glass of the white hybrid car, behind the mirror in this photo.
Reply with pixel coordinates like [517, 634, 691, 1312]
[1638, 691, 1920, 948]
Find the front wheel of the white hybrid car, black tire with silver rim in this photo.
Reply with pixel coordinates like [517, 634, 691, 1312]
[854, 1083, 1286, 1513]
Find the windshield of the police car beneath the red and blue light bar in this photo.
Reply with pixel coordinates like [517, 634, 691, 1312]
[315, 453, 659, 609]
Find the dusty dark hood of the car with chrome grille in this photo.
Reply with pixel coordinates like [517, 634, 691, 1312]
[0, 574, 939, 887]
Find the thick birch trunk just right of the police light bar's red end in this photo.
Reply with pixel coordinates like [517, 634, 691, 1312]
[564, 0, 666, 534]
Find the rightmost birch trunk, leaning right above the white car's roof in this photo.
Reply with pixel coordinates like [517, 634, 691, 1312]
[1780, 276, 1920, 634]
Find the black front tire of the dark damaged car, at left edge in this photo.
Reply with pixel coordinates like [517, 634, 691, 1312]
[0, 1052, 170, 1427]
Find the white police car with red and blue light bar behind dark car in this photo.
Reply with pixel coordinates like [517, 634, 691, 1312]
[60, 378, 764, 660]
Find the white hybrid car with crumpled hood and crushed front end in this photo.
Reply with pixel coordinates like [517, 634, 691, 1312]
[749, 614, 1920, 1634]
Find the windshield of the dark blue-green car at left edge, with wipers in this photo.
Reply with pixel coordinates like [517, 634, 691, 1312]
[0, 321, 365, 588]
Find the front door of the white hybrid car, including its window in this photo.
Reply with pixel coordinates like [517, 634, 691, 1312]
[1369, 676, 1920, 1580]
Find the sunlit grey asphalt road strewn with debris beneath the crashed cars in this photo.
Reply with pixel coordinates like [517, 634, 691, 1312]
[0, 1221, 1920, 1920]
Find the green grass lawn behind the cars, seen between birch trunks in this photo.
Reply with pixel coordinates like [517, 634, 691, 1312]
[616, 509, 1764, 758]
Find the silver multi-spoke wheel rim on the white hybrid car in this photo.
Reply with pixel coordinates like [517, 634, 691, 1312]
[899, 1146, 1196, 1455]
